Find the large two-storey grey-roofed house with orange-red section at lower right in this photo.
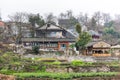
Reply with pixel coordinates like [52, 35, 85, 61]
[22, 23, 75, 50]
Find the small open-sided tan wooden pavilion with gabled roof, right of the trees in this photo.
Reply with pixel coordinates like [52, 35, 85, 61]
[86, 41, 111, 56]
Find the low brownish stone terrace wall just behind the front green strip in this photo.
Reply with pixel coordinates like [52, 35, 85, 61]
[46, 66, 120, 73]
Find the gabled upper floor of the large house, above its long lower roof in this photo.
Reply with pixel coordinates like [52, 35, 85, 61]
[35, 23, 75, 38]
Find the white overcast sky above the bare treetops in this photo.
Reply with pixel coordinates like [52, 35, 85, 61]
[0, 0, 120, 20]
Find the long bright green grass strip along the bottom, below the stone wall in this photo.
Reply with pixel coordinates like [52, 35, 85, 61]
[13, 72, 118, 79]
